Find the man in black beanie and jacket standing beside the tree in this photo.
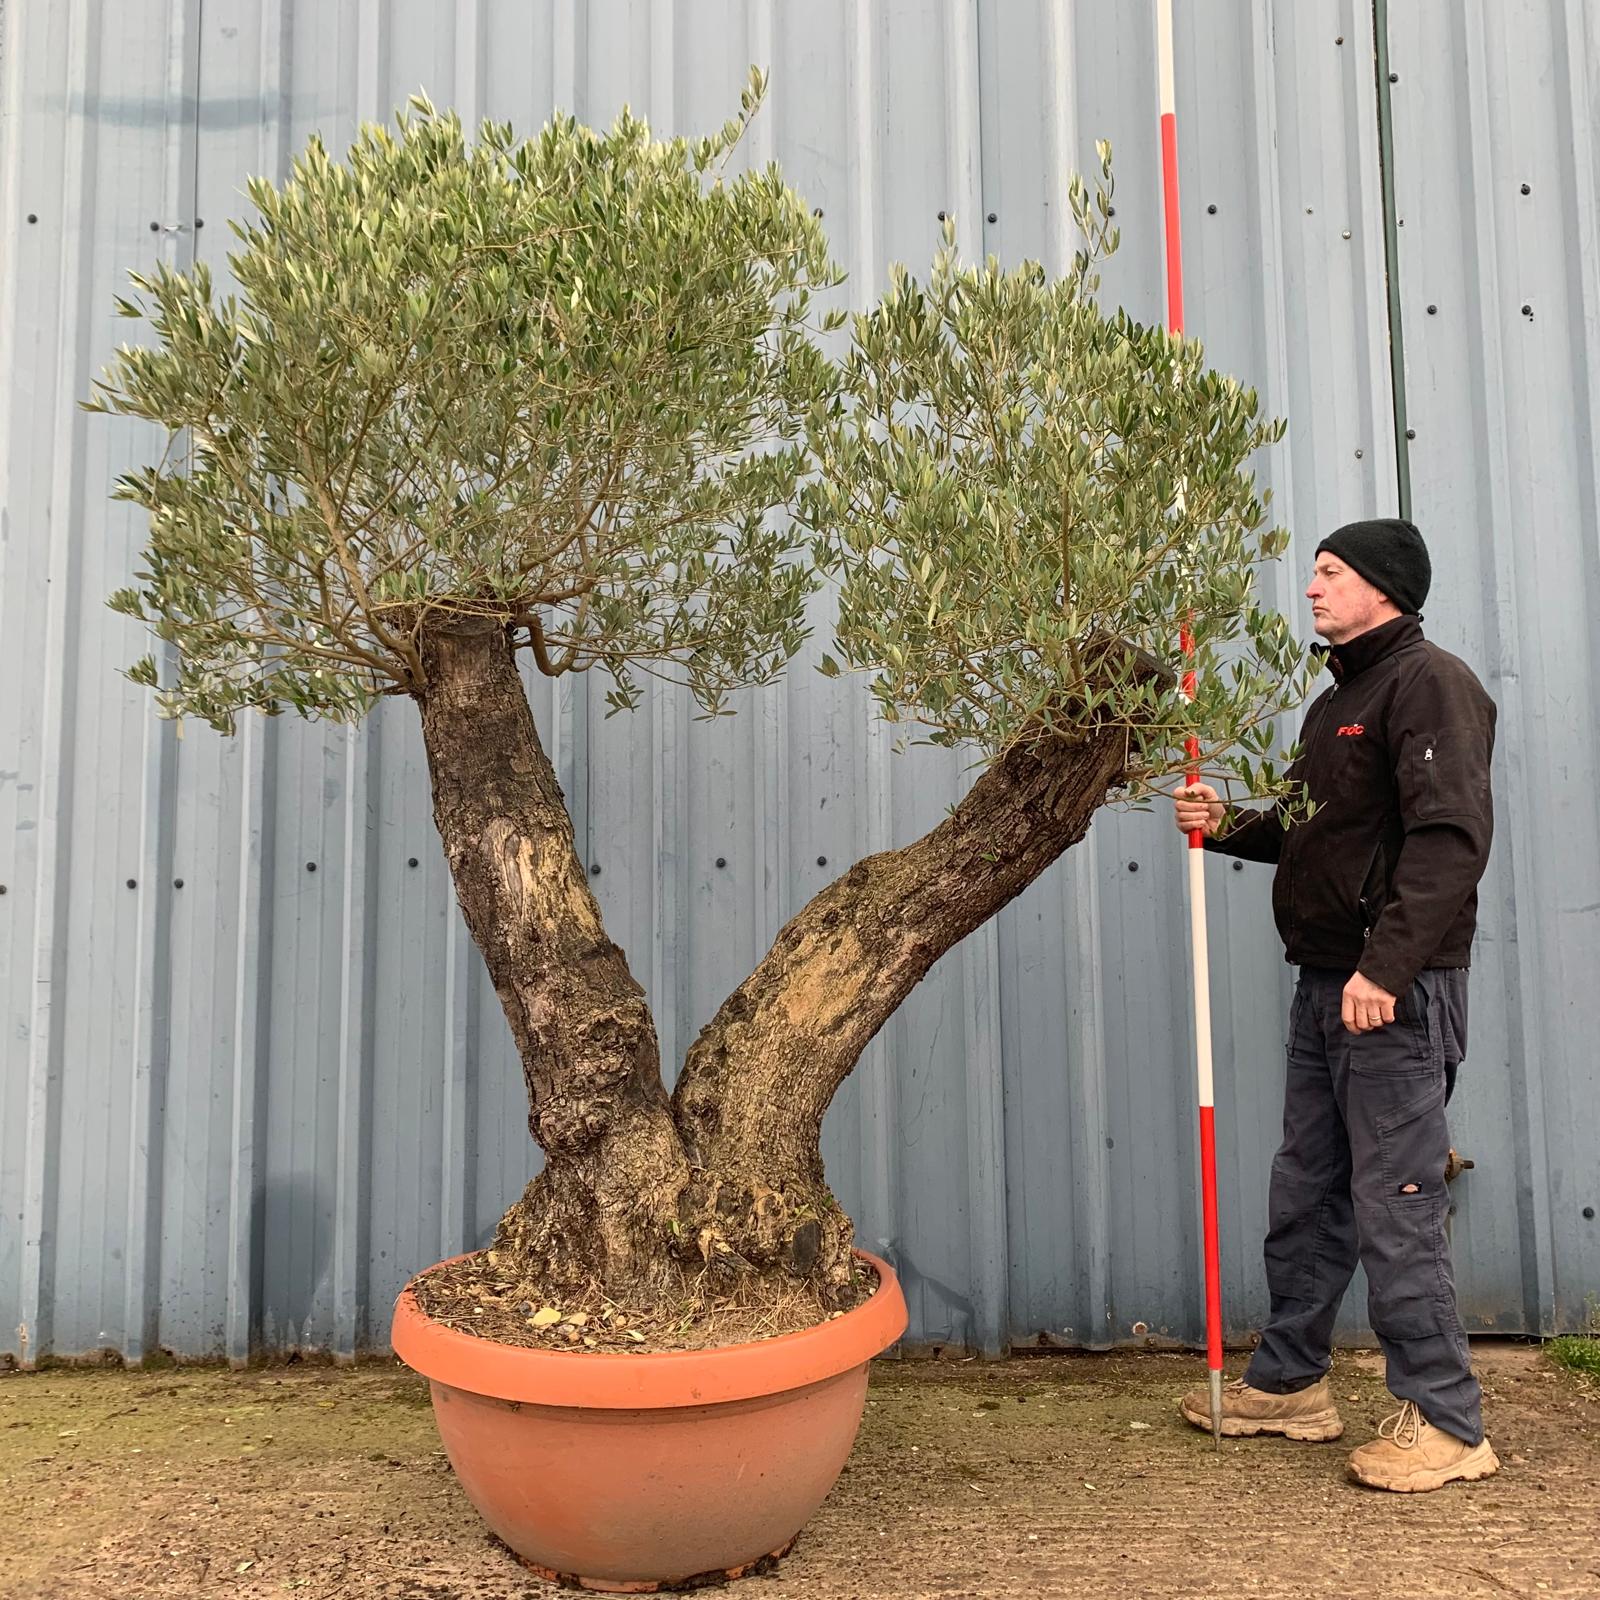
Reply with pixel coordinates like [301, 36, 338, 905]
[1176, 520, 1499, 1490]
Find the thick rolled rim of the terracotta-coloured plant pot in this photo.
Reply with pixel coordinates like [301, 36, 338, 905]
[390, 1250, 907, 1410]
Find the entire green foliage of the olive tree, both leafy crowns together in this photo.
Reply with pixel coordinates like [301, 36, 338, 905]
[90, 74, 1306, 790]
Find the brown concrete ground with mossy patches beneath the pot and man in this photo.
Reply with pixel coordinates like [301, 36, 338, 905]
[0, 1344, 1600, 1600]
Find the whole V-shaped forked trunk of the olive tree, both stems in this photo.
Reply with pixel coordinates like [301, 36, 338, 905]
[418, 618, 1125, 1307]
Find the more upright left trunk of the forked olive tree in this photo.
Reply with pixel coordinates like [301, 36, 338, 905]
[419, 618, 690, 1298]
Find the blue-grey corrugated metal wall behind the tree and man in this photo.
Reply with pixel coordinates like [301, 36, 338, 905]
[0, 0, 1600, 1358]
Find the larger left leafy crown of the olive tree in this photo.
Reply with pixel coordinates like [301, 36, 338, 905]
[91, 73, 840, 728]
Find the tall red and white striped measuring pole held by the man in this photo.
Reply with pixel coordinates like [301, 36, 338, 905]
[1155, 0, 1222, 1443]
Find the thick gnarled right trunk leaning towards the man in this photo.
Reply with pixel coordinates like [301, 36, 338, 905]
[674, 730, 1125, 1294]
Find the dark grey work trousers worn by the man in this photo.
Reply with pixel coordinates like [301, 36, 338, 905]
[1245, 966, 1483, 1445]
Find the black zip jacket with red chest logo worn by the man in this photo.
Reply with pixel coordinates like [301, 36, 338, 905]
[1206, 616, 1494, 995]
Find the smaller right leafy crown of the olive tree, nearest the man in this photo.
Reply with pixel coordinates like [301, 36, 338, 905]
[803, 142, 1306, 800]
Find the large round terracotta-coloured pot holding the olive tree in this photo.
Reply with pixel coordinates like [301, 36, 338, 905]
[392, 1251, 906, 1592]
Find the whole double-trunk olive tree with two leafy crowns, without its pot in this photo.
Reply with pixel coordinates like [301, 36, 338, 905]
[91, 84, 1301, 1337]
